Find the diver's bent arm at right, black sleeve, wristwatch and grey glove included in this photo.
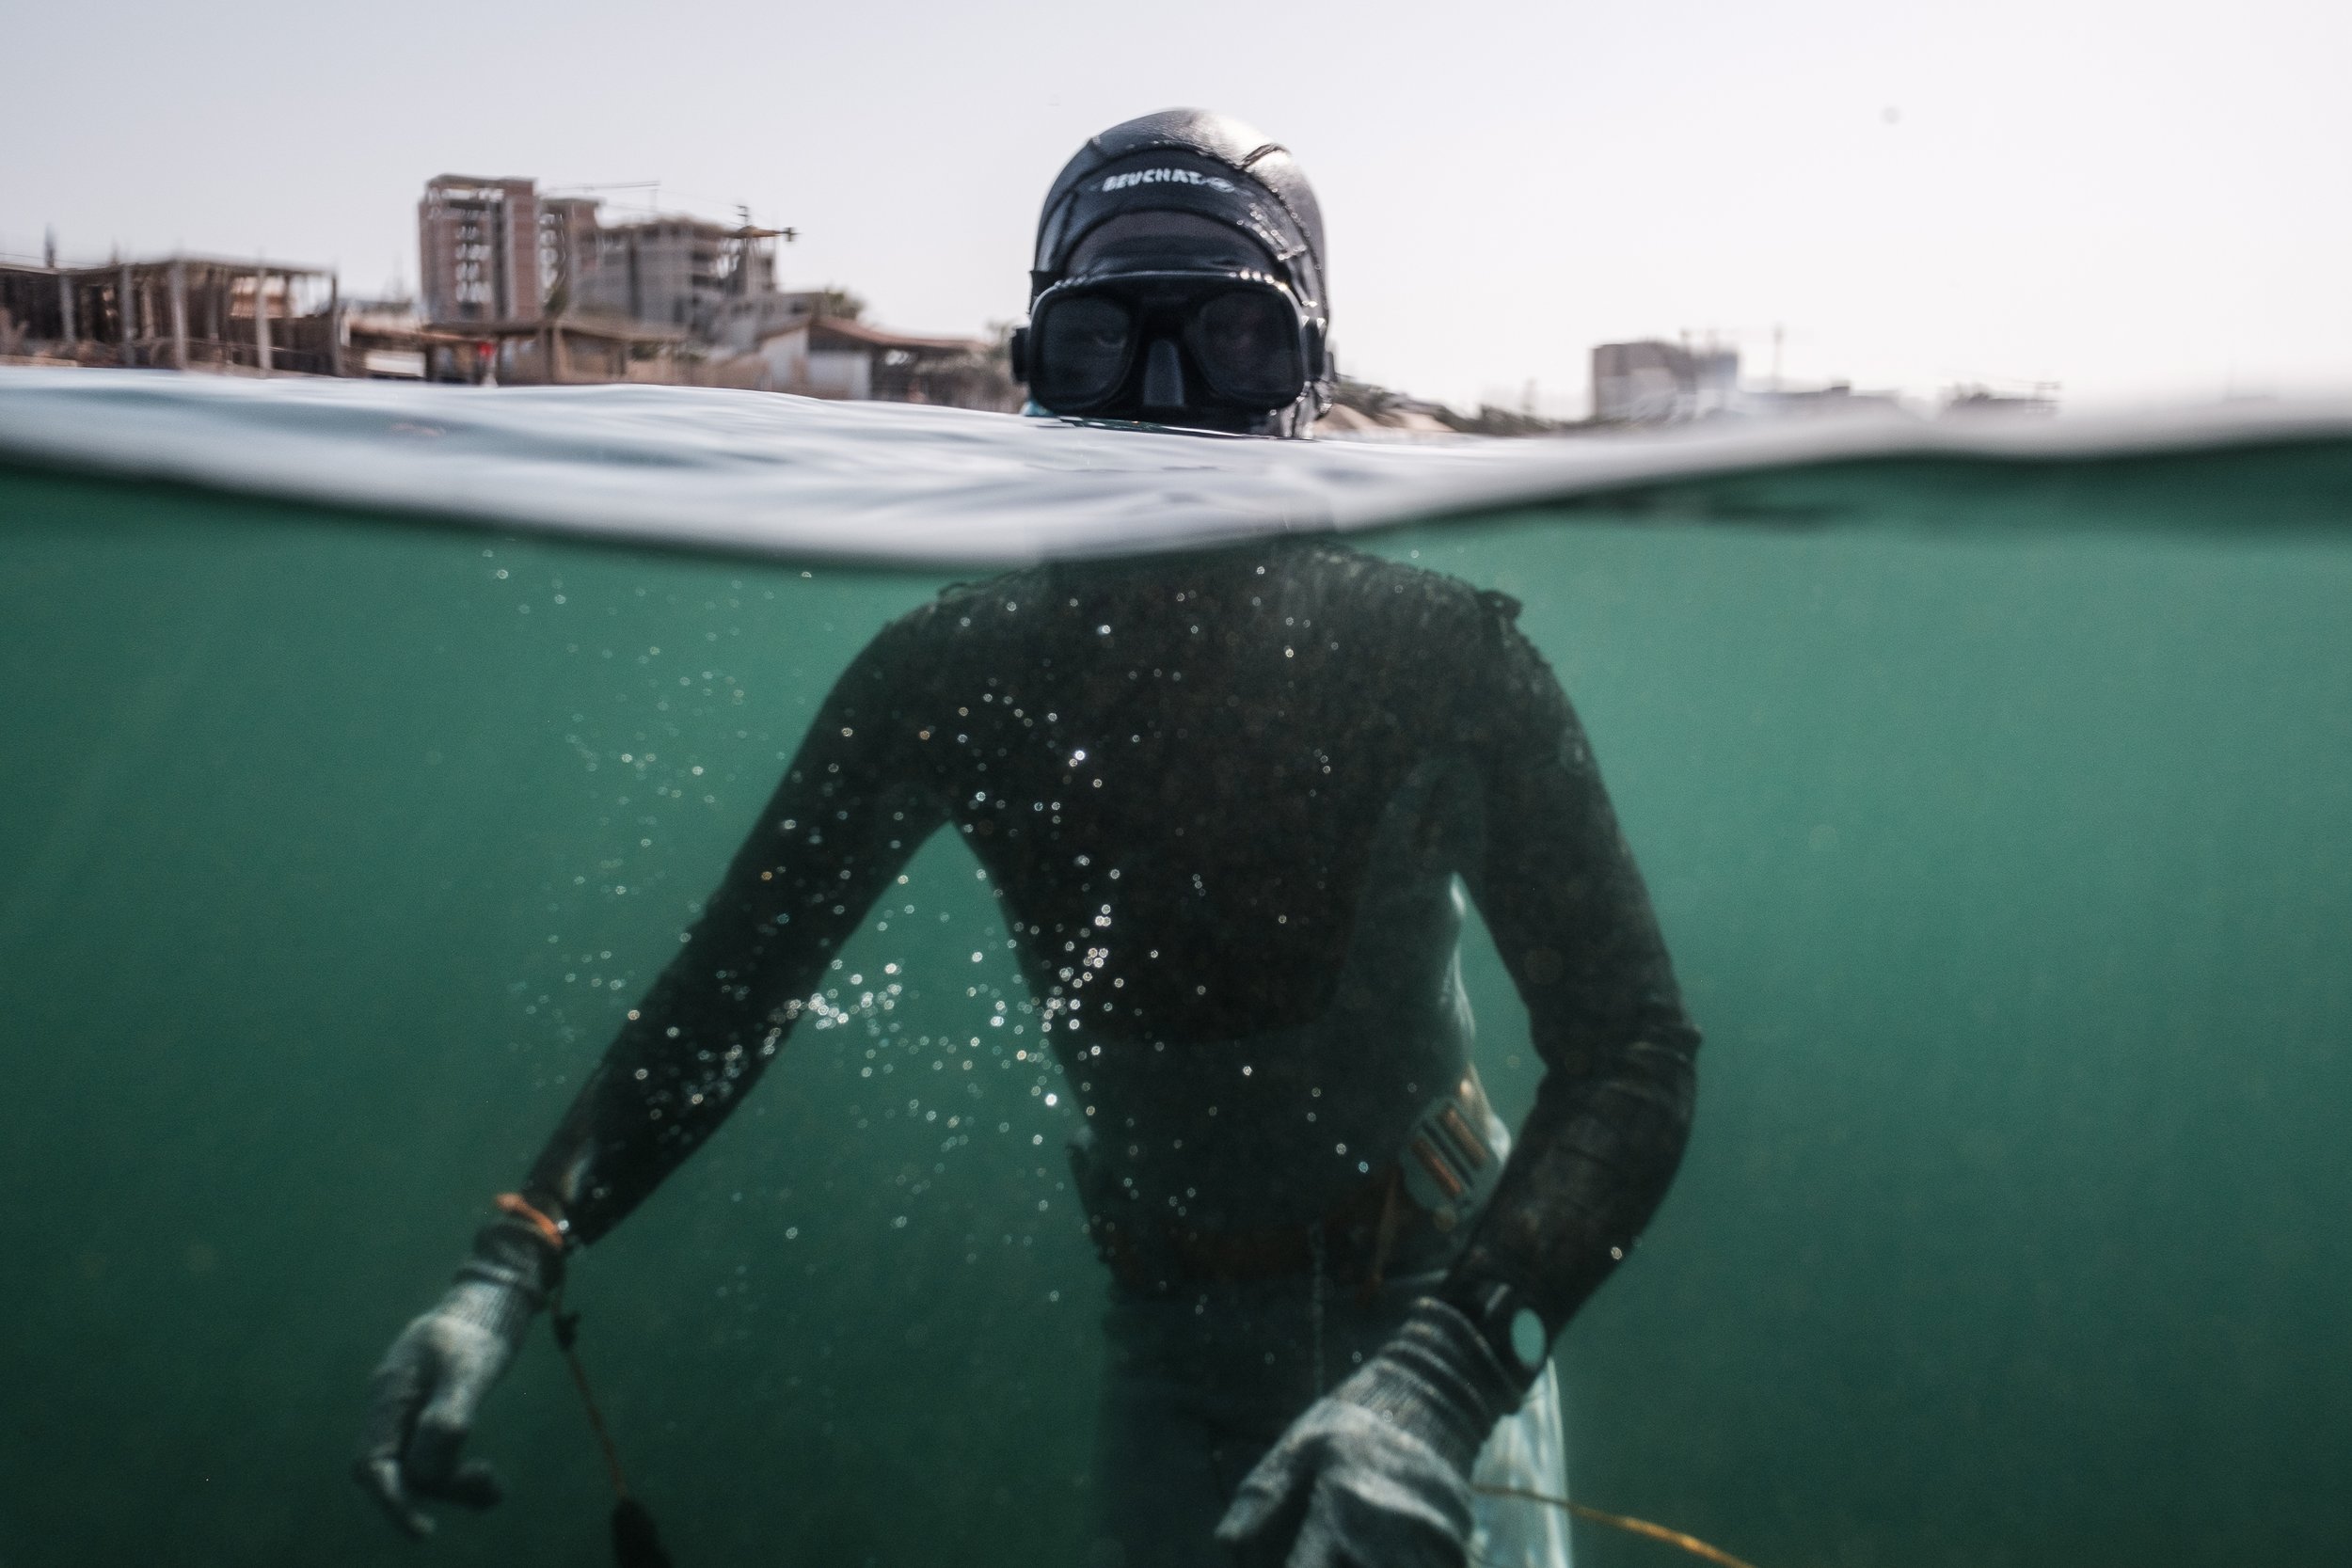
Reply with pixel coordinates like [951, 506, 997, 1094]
[1218, 594, 1698, 1568]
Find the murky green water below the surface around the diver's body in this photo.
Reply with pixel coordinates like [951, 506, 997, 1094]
[0, 472, 2352, 1568]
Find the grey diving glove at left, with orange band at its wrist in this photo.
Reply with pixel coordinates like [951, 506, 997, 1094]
[351, 1220, 563, 1538]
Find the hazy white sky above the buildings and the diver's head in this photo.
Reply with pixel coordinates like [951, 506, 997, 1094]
[0, 0, 2352, 409]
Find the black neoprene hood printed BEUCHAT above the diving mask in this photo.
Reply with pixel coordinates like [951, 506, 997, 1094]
[1030, 108, 1331, 317]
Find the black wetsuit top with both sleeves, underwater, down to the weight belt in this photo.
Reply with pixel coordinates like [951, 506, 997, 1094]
[527, 541, 1698, 1331]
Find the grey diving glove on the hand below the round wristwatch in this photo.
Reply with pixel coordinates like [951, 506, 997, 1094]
[1216, 1298, 1524, 1568]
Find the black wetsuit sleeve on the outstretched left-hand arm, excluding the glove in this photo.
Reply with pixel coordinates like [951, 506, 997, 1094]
[525, 611, 946, 1243]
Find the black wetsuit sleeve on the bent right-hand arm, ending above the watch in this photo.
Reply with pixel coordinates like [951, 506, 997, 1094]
[1444, 594, 1698, 1333]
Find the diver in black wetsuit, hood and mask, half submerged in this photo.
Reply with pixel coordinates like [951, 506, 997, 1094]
[356, 110, 1698, 1568]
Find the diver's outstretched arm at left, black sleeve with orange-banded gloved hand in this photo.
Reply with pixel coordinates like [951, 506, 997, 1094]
[353, 611, 946, 1535]
